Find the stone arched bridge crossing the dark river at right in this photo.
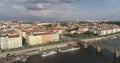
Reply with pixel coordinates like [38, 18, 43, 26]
[75, 39, 120, 58]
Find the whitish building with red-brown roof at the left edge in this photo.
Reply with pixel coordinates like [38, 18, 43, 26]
[0, 32, 22, 49]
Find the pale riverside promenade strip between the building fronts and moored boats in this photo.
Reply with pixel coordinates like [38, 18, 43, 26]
[0, 41, 77, 58]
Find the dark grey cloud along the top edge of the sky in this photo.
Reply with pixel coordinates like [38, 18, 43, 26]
[9, 0, 78, 10]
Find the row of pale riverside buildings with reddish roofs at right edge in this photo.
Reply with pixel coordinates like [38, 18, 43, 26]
[90, 24, 120, 36]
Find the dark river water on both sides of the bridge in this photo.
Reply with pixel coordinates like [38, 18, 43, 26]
[14, 38, 120, 63]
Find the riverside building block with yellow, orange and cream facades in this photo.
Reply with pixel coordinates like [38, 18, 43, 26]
[26, 32, 59, 45]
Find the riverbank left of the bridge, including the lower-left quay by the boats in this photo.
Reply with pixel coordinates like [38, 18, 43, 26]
[0, 41, 77, 63]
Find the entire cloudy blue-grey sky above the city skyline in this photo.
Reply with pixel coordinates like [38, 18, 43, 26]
[0, 0, 120, 21]
